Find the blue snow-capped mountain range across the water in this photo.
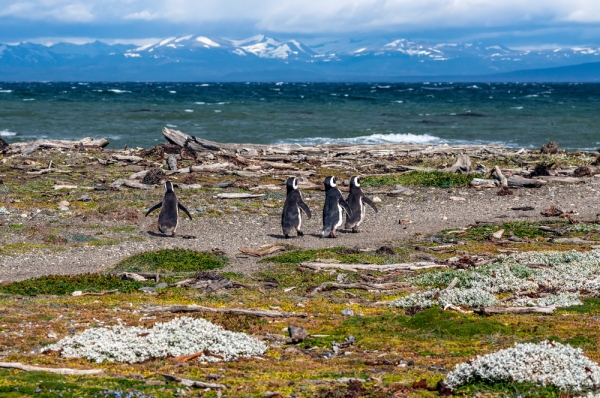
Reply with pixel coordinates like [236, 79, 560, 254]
[0, 35, 600, 82]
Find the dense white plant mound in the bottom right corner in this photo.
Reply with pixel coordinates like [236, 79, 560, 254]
[445, 341, 600, 392]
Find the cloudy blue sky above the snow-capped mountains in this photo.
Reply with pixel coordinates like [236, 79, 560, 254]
[0, 0, 600, 48]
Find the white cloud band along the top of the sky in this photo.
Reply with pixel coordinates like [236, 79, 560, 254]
[0, 0, 600, 33]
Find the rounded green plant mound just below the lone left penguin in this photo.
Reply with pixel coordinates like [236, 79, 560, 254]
[111, 249, 227, 272]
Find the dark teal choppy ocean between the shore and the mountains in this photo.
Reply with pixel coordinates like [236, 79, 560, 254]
[0, 82, 600, 150]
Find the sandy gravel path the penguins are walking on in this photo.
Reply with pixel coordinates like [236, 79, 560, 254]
[0, 183, 600, 281]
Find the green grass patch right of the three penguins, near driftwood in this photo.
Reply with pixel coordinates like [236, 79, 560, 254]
[361, 171, 474, 188]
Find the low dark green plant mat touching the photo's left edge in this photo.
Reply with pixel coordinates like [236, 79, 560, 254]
[0, 274, 144, 296]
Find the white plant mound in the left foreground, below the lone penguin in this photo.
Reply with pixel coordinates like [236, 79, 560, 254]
[43, 317, 267, 363]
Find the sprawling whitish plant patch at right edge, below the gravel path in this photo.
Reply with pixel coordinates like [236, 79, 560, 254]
[391, 250, 600, 307]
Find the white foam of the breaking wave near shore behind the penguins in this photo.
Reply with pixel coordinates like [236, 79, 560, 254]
[278, 134, 440, 145]
